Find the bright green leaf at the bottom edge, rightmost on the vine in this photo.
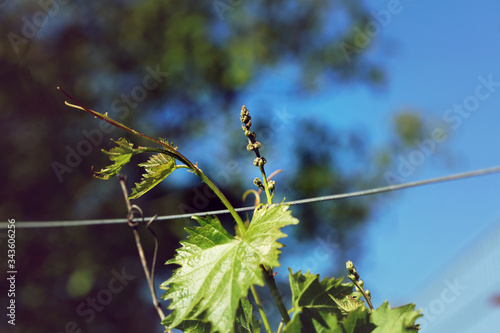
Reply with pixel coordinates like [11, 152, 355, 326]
[370, 301, 423, 333]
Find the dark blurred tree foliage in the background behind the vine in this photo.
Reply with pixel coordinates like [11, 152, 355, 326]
[0, 0, 434, 332]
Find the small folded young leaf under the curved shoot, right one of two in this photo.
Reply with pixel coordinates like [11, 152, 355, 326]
[129, 153, 177, 199]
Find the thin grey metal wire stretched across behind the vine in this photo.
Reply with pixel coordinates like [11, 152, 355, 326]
[0, 166, 500, 229]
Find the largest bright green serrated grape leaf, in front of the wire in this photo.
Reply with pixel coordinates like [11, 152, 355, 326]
[162, 204, 298, 332]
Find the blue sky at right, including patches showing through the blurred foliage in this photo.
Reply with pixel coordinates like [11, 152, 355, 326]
[232, 0, 500, 332]
